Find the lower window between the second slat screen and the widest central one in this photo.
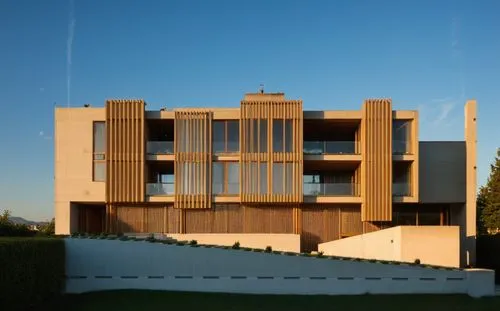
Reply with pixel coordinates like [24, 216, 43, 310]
[212, 162, 240, 195]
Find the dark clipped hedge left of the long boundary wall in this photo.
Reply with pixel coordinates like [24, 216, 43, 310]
[0, 237, 65, 310]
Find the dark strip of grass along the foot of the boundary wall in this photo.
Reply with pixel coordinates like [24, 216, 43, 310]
[41, 290, 500, 311]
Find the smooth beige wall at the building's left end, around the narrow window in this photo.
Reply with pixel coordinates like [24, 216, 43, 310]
[54, 108, 105, 234]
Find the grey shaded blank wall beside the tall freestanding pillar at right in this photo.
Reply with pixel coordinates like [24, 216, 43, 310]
[419, 141, 466, 203]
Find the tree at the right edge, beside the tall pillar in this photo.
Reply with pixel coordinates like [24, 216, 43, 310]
[477, 148, 500, 233]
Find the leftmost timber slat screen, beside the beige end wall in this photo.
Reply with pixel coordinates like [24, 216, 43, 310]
[106, 100, 145, 203]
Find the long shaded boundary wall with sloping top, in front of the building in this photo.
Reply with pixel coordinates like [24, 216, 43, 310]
[65, 239, 495, 297]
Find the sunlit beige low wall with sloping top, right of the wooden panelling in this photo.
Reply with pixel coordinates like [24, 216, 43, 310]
[318, 226, 460, 267]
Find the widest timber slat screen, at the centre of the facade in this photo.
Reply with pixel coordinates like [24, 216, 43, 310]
[240, 98, 303, 204]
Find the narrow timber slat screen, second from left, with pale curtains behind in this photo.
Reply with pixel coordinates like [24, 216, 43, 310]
[174, 109, 212, 209]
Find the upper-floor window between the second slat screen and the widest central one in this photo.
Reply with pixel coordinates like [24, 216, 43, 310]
[212, 120, 240, 153]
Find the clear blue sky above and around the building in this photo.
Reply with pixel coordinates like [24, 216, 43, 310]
[0, 0, 500, 220]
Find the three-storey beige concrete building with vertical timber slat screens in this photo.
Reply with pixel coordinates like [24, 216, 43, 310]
[55, 92, 476, 265]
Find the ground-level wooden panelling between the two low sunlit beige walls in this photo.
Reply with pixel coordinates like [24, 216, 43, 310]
[300, 204, 340, 252]
